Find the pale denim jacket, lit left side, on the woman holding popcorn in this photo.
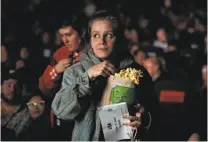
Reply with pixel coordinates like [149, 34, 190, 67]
[52, 50, 154, 141]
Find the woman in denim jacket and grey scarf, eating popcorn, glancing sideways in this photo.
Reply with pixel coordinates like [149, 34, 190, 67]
[52, 11, 154, 141]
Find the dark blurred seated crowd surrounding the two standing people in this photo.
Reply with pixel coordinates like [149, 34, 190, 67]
[1, 0, 207, 140]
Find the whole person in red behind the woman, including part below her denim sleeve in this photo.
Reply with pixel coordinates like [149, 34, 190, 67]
[39, 15, 84, 140]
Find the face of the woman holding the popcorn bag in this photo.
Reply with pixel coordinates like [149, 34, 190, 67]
[90, 20, 116, 60]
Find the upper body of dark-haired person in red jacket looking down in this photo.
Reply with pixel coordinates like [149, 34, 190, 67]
[39, 17, 83, 98]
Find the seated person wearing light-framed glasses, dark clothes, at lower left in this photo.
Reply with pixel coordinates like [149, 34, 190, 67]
[19, 93, 51, 141]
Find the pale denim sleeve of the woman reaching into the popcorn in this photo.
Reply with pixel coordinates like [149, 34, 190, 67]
[52, 68, 91, 120]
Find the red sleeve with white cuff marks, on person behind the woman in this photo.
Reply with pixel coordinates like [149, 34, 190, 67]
[39, 65, 61, 97]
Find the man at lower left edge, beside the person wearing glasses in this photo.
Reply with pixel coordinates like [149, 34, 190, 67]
[1, 70, 31, 140]
